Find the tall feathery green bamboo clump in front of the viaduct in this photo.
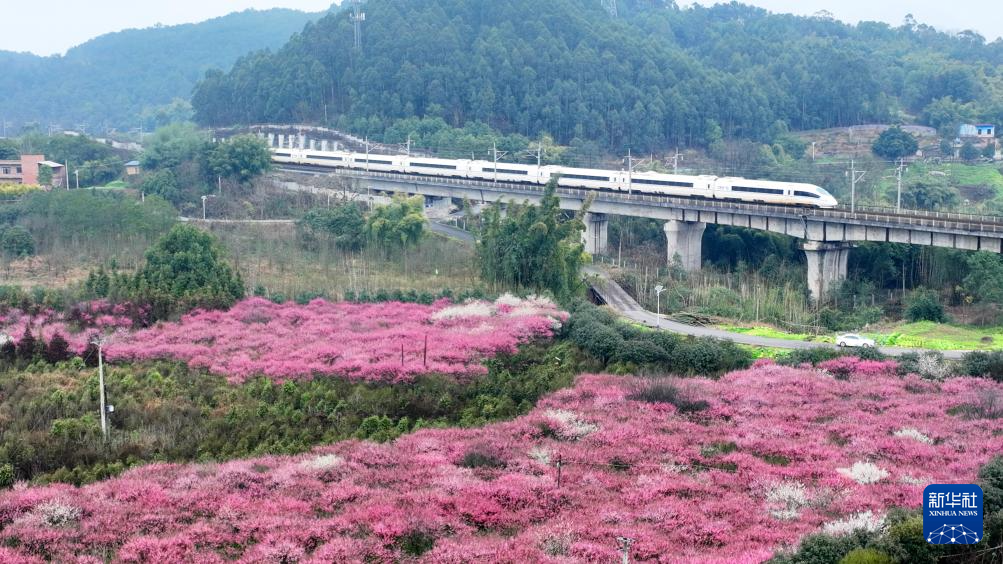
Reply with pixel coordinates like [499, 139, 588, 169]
[476, 179, 585, 297]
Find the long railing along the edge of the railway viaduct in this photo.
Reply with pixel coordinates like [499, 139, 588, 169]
[300, 169, 1003, 233]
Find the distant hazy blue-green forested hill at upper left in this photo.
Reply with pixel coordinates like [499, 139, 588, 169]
[0, 9, 322, 130]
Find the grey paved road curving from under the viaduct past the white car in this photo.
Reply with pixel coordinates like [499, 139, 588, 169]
[585, 266, 968, 359]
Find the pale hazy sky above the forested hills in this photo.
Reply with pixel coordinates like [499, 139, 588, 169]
[0, 0, 1003, 55]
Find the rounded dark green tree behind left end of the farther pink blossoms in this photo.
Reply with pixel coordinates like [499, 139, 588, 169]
[134, 225, 244, 316]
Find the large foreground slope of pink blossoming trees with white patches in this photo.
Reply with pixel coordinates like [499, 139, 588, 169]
[0, 357, 1003, 563]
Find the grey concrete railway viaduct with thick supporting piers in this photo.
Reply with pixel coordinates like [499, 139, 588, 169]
[221, 124, 1003, 299]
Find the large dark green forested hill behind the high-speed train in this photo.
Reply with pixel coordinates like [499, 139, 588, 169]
[193, 0, 1003, 150]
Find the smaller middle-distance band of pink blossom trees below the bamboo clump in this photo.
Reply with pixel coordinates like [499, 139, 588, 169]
[107, 295, 567, 382]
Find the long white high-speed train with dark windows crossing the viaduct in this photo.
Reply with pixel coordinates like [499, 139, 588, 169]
[272, 149, 838, 208]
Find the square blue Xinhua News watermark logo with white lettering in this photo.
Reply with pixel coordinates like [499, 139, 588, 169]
[923, 484, 982, 544]
